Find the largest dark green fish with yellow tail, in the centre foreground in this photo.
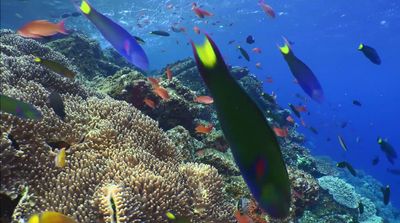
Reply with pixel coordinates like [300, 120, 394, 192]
[191, 35, 291, 218]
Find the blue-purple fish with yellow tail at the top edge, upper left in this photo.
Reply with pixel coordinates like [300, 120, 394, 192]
[74, 0, 149, 70]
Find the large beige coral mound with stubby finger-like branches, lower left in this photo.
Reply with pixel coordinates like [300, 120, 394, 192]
[0, 30, 233, 223]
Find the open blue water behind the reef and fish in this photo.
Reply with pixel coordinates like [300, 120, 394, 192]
[1, 0, 400, 207]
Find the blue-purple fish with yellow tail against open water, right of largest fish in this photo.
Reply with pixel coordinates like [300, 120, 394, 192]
[279, 41, 324, 103]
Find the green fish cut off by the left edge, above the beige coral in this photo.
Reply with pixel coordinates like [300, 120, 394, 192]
[0, 94, 42, 120]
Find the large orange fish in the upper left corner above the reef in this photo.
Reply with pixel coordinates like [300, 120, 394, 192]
[17, 20, 68, 38]
